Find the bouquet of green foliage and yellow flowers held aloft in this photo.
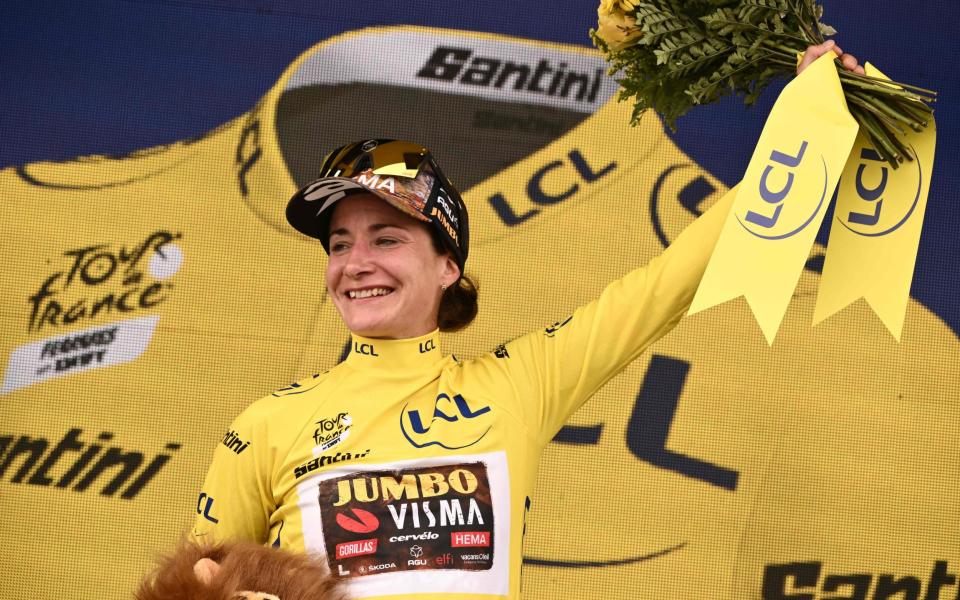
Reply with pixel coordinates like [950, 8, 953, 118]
[590, 0, 936, 168]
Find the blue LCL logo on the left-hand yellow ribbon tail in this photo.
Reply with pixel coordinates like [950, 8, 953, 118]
[737, 140, 827, 240]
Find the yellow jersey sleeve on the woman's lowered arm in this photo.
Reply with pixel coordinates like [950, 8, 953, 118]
[192, 399, 275, 543]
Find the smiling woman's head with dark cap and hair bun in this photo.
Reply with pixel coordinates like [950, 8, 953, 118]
[287, 140, 477, 339]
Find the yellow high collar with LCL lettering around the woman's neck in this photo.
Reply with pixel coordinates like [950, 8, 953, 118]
[345, 329, 444, 372]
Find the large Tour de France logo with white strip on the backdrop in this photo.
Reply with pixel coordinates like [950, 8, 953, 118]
[0, 229, 183, 393]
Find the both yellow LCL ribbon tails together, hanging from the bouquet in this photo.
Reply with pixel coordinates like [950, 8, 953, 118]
[689, 52, 935, 344]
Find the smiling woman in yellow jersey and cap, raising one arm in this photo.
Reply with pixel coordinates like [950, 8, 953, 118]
[194, 42, 857, 600]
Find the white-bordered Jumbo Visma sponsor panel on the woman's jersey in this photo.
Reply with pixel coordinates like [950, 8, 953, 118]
[297, 452, 510, 598]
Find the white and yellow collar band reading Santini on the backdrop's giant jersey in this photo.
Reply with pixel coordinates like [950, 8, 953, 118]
[238, 25, 617, 243]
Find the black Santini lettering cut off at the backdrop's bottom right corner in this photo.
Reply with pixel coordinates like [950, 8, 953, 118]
[761, 560, 957, 600]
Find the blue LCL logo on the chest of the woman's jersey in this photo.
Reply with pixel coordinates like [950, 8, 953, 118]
[400, 394, 491, 450]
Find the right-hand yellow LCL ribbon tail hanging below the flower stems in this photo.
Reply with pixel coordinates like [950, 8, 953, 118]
[813, 64, 937, 341]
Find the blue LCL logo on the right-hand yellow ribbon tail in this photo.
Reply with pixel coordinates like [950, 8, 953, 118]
[836, 146, 923, 237]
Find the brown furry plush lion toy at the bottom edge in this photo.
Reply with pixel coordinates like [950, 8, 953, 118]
[135, 542, 347, 600]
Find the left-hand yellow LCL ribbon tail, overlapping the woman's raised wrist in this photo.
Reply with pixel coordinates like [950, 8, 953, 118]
[690, 53, 857, 344]
